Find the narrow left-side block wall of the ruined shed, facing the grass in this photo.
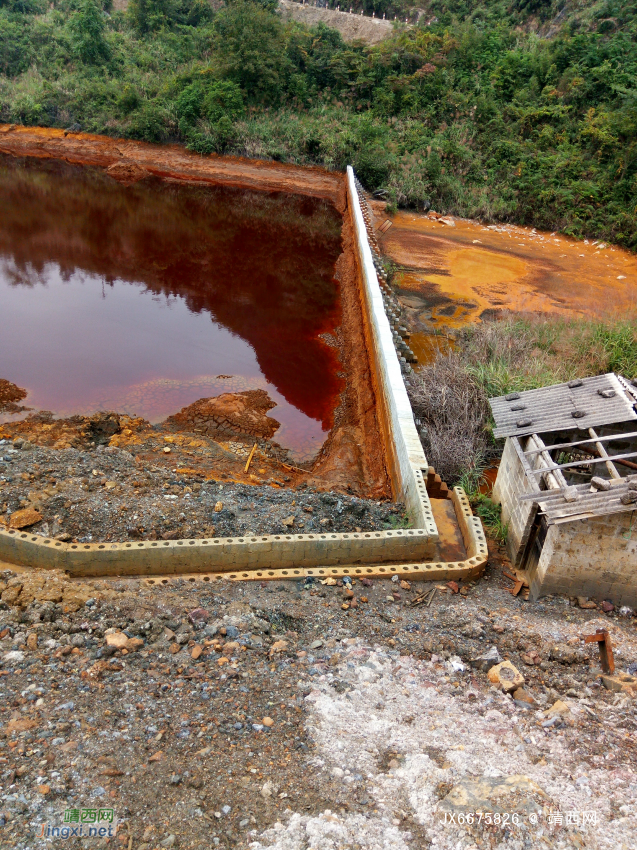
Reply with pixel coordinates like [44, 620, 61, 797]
[493, 437, 539, 567]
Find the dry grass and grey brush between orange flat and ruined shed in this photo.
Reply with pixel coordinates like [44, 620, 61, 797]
[407, 316, 637, 484]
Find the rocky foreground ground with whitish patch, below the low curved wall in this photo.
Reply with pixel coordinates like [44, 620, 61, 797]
[0, 548, 637, 850]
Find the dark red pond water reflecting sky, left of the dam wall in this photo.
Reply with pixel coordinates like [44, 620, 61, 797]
[0, 156, 342, 460]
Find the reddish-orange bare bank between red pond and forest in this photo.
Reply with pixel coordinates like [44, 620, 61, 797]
[0, 124, 346, 212]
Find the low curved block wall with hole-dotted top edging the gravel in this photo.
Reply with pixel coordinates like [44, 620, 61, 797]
[0, 487, 487, 581]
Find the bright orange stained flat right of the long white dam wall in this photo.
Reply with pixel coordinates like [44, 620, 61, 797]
[375, 205, 637, 362]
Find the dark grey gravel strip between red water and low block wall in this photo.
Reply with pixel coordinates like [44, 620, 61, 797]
[0, 440, 404, 543]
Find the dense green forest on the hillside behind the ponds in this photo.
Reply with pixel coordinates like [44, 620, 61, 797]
[0, 0, 637, 249]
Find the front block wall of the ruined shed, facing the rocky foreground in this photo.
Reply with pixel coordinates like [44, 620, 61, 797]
[529, 511, 637, 607]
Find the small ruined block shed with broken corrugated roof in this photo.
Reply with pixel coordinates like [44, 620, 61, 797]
[491, 374, 637, 606]
